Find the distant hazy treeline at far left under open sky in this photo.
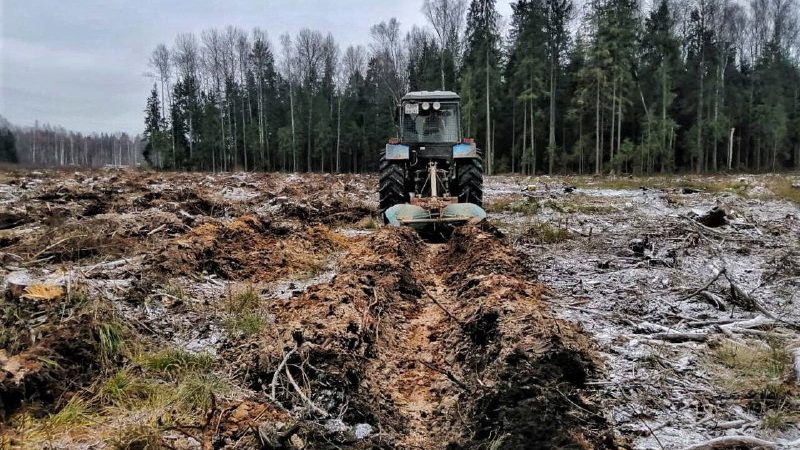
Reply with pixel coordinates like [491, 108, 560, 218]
[8, 122, 145, 167]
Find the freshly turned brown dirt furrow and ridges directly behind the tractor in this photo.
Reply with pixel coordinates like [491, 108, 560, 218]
[248, 228, 618, 449]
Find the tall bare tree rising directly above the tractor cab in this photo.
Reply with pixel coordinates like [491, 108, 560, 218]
[422, 0, 467, 90]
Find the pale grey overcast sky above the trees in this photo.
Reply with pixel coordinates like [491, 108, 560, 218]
[0, 0, 511, 133]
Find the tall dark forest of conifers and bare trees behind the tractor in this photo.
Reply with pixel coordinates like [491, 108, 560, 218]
[144, 0, 800, 173]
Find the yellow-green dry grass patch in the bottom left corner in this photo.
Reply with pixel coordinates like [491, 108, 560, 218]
[11, 349, 233, 449]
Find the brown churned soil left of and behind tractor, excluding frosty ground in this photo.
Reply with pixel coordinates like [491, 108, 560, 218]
[0, 169, 629, 449]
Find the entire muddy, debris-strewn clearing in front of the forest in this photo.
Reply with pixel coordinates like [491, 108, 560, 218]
[0, 170, 800, 449]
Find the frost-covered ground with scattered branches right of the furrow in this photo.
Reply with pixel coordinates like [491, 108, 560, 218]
[487, 176, 800, 449]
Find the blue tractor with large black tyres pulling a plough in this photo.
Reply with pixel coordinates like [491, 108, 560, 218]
[379, 91, 486, 229]
